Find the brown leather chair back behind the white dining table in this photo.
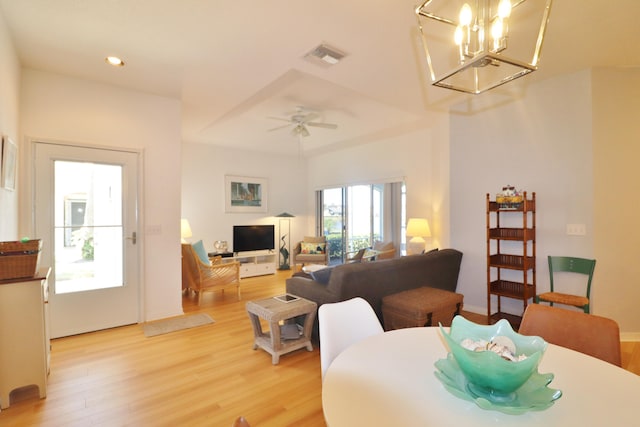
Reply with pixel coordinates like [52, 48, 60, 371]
[518, 304, 622, 366]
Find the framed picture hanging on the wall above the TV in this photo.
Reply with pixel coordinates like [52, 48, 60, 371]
[224, 175, 267, 212]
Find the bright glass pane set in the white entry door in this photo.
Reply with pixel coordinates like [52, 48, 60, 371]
[54, 161, 124, 294]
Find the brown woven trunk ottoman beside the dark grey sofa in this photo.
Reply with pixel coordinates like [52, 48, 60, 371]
[382, 287, 463, 331]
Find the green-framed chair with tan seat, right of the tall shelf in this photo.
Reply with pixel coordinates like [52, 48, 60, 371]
[535, 256, 596, 313]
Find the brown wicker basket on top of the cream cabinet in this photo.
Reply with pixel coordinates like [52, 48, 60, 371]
[0, 239, 42, 280]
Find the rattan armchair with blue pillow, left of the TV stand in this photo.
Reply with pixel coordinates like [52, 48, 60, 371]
[182, 243, 240, 305]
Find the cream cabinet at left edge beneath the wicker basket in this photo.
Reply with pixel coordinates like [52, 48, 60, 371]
[0, 268, 51, 409]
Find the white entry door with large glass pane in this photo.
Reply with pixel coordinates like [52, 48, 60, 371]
[34, 142, 140, 338]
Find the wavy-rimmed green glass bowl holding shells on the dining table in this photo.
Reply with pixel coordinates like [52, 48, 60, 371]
[440, 316, 547, 401]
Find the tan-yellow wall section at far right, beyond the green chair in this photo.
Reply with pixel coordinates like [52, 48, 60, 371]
[593, 68, 640, 340]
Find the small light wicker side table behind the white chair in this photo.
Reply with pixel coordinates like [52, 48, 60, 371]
[246, 297, 318, 365]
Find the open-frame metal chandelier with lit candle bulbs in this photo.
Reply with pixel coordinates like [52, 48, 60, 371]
[415, 0, 552, 94]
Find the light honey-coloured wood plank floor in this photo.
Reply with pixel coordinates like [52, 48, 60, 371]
[0, 272, 640, 427]
